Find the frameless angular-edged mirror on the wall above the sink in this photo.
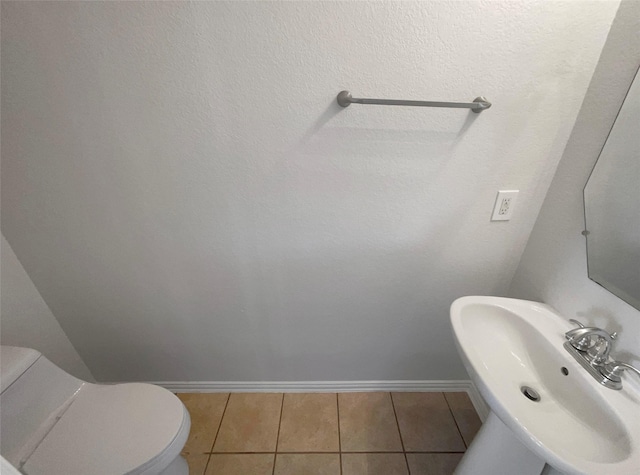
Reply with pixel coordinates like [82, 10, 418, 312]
[584, 66, 640, 310]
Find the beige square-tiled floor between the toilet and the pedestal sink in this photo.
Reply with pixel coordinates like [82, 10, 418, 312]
[178, 393, 481, 475]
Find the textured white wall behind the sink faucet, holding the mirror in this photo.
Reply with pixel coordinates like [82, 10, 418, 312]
[509, 0, 640, 372]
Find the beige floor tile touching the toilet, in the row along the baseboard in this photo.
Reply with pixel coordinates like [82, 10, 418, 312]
[177, 393, 229, 454]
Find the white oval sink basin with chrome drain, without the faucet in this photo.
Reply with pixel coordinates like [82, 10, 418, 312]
[451, 297, 640, 475]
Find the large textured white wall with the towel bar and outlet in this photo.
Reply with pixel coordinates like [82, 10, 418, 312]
[2, 1, 617, 380]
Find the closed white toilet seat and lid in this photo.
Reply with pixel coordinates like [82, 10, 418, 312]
[23, 383, 191, 475]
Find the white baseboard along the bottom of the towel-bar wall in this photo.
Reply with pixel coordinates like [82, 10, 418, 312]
[149, 380, 489, 421]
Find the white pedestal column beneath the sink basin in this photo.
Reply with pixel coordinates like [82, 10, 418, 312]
[455, 412, 545, 475]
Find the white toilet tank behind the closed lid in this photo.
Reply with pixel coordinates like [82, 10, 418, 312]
[0, 345, 84, 469]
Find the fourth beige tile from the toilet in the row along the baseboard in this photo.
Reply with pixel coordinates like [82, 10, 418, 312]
[338, 393, 402, 452]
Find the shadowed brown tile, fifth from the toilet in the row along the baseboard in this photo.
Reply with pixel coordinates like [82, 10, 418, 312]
[392, 393, 465, 452]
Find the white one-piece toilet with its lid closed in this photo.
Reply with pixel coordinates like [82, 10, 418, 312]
[0, 346, 191, 475]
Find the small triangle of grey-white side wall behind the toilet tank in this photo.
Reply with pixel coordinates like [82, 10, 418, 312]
[0, 236, 93, 381]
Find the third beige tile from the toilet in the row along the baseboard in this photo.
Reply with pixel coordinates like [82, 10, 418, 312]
[278, 394, 340, 452]
